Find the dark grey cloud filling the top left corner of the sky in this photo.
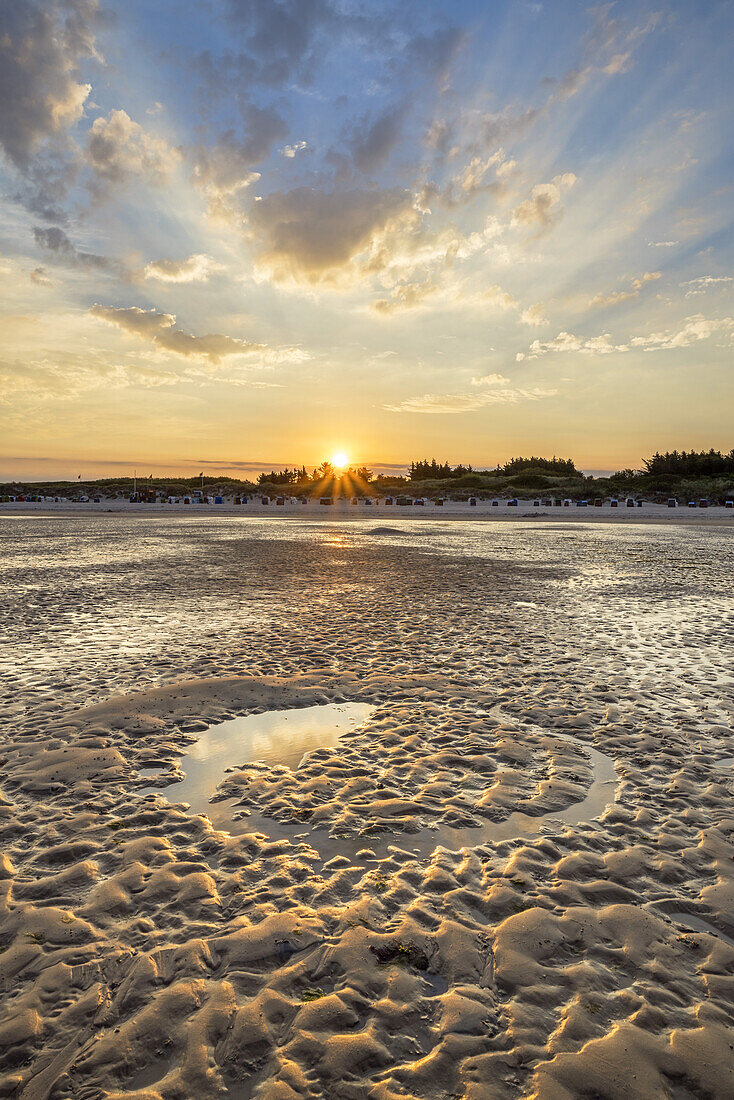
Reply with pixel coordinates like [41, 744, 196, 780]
[0, 0, 99, 171]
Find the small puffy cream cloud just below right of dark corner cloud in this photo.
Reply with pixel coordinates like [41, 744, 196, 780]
[86, 111, 180, 197]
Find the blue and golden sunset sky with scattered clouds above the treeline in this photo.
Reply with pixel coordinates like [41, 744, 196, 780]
[0, 0, 734, 479]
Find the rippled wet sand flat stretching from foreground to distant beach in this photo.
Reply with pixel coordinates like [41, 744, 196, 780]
[0, 514, 734, 1100]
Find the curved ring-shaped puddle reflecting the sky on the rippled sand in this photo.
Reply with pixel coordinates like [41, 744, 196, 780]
[141, 703, 617, 865]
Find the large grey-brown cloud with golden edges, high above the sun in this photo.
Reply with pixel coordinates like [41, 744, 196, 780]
[249, 187, 417, 283]
